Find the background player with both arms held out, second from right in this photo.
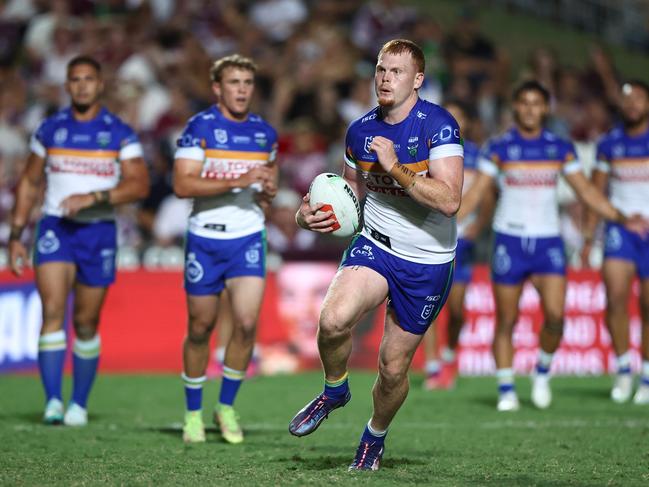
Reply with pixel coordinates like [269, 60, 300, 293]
[463, 81, 648, 411]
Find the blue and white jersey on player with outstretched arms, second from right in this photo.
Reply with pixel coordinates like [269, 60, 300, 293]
[478, 128, 581, 237]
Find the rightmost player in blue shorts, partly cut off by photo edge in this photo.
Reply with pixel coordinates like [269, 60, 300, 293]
[582, 81, 649, 404]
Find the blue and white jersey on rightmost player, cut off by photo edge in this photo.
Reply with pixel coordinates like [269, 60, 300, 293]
[596, 127, 649, 217]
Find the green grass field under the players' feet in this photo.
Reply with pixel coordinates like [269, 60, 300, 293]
[0, 372, 649, 486]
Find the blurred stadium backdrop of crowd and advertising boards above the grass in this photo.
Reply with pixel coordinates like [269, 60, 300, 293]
[0, 0, 649, 375]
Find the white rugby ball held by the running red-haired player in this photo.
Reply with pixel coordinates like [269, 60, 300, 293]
[309, 172, 361, 237]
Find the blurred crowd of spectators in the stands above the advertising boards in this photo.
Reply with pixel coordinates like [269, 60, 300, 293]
[0, 0, 636, 266]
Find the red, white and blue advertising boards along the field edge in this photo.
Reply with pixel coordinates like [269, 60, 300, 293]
[0, 262, 641, 375]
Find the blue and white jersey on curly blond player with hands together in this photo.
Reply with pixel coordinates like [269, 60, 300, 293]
[175, 106, 277, 239]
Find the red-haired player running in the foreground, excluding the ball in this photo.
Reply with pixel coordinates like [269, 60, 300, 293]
[289, 39, 463, 470]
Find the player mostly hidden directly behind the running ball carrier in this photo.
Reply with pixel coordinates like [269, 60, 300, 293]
[424, 101, 494, 390]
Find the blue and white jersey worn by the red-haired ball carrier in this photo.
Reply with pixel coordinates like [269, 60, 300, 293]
[345, 99, 464, 264]
